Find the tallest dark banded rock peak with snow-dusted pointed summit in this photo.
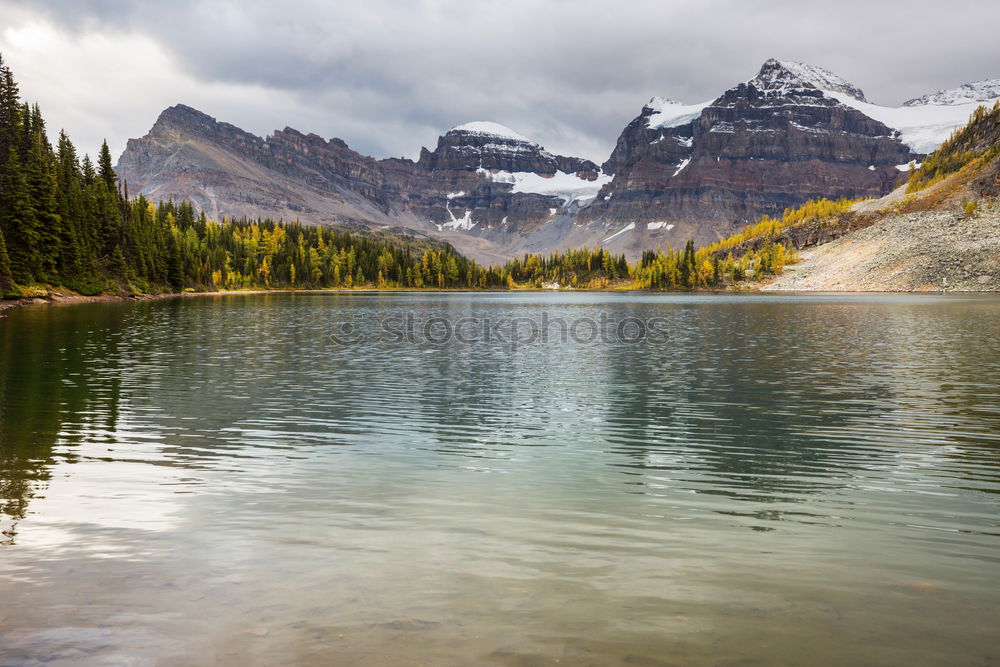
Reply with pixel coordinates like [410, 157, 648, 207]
[581, 60, 916, 242]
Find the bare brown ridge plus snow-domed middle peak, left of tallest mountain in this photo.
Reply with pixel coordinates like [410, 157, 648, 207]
[117, 105, 610, 262]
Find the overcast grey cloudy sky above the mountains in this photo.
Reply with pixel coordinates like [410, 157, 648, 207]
[0, 0, 1000, 161]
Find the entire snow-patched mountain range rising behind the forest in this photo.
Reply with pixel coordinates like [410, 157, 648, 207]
[117, 60, 1000, 262]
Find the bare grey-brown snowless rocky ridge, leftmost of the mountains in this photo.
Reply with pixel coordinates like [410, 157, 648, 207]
[118, 105, 393, 224]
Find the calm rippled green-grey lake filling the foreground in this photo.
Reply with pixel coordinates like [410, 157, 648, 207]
[0, 293, 1000, 666]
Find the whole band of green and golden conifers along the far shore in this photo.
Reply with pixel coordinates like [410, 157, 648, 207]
[0, 57, 812, 296]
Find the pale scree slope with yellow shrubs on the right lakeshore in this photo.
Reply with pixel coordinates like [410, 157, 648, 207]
[762, 103, 1000, 292]
